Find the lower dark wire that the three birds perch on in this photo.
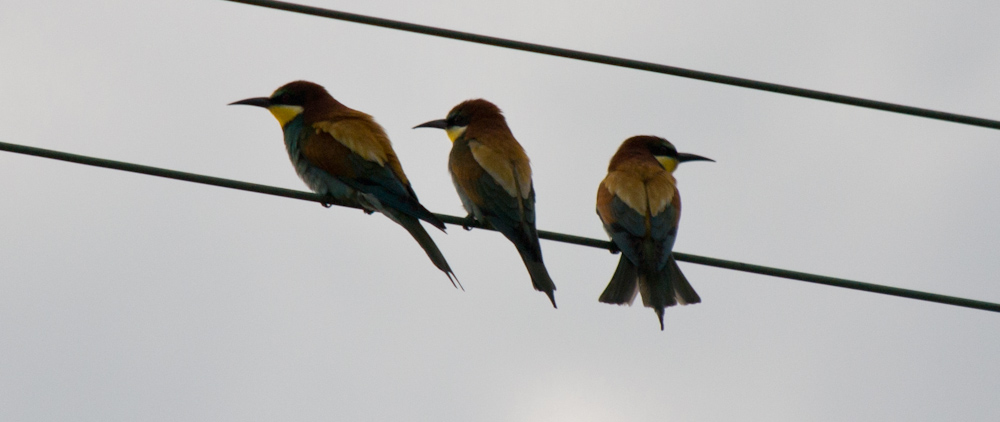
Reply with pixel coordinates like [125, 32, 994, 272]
[0, 142, 1000, 312]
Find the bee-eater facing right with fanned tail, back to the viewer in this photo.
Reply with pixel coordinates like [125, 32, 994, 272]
[597, 136, 714, 330]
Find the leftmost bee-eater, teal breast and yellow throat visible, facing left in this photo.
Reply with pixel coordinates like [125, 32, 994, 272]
[230, 81, 461, 287]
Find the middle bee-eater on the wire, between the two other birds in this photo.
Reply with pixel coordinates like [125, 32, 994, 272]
[414, 99, 556, 307]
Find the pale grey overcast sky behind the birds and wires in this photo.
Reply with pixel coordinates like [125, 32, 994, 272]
[0, 0, 1000, 421]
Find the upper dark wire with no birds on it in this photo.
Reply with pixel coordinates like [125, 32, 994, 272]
[225, 0, 1000, 129]
